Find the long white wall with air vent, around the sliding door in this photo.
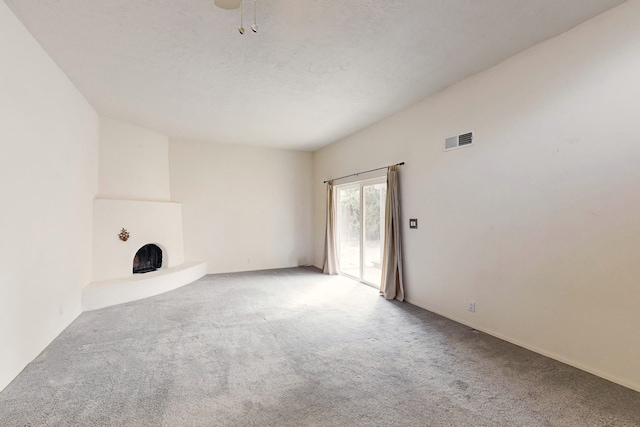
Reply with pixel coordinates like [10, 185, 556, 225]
[314, 1, 640, 390]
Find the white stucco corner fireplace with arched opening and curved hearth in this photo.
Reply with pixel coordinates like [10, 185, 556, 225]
[82, 199, 206, 311]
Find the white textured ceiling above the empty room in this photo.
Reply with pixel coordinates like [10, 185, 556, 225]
[4, 0, 624, 150]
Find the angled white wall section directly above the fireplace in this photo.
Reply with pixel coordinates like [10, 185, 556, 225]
[98, 117, 171, 201]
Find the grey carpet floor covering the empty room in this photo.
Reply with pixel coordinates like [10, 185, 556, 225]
[0, 268, 640, 427]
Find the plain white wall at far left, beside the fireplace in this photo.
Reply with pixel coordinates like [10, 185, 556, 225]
[0, 2, 98, 389]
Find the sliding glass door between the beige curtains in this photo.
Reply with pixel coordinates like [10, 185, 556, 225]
[336, 179, 387, 287]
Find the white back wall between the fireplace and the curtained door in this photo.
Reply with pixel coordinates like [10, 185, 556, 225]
[169, 139, 313, 273]
